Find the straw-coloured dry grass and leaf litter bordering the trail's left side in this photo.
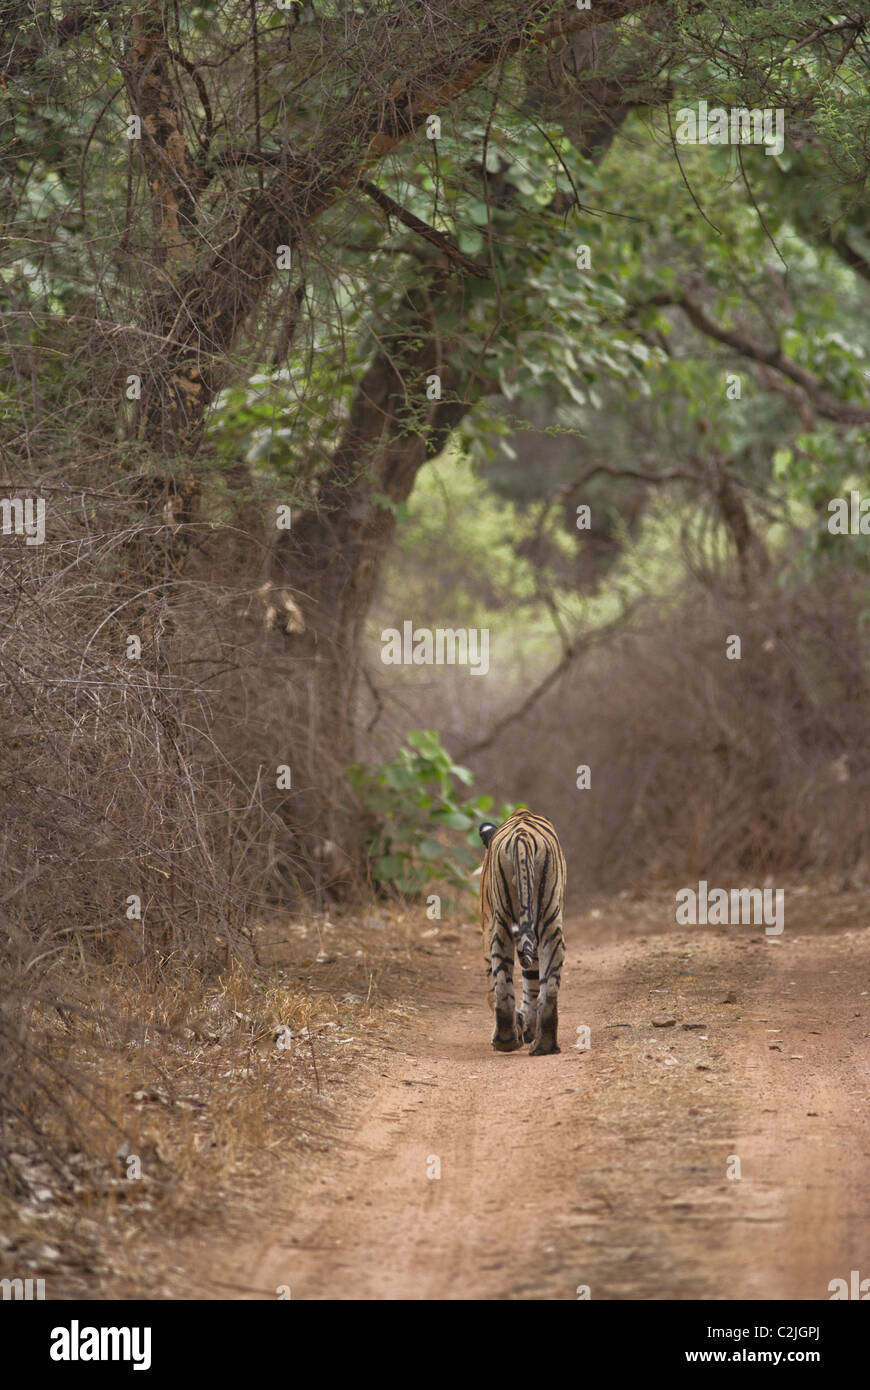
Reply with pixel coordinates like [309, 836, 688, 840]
[0, 909, 439, 1298]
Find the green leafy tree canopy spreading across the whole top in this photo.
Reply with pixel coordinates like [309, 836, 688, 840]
[6, 0, 870, 608]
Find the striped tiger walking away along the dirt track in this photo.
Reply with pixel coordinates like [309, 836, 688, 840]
[479, 810, 566, 1056]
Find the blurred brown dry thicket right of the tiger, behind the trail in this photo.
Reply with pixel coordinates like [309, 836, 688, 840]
[471, 575, 870, 902]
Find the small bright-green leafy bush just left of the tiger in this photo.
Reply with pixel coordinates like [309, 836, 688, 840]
[350, 728, 516, 897]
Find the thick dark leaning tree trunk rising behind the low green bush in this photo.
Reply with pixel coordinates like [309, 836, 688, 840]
[272, 311, 473, 845]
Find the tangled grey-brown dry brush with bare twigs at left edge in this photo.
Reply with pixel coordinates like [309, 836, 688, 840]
[0, 488, 358, 1206]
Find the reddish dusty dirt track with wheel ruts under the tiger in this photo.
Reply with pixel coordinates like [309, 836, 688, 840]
[235, 919, 870, 1300]
